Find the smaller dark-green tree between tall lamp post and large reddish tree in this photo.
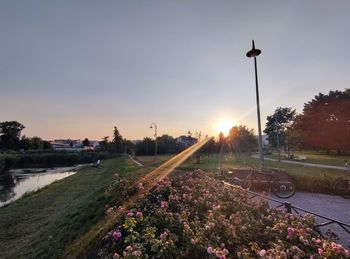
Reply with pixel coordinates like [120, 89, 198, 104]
[264, 107, 296, 152]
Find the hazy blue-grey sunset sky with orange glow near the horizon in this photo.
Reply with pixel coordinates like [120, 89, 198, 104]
[0, 0, 350, 140]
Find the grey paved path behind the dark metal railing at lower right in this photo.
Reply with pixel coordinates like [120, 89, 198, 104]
[269, 192, 350, 248]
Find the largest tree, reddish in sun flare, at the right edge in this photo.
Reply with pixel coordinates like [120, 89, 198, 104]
[293, 89, 350, 153]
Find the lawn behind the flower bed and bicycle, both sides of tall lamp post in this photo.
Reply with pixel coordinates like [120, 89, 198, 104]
[179, 154, 350, 194]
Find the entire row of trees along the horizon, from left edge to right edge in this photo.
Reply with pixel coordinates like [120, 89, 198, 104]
[0, 89, 350, 155]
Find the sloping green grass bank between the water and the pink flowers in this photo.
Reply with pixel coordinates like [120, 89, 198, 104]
[0, 157, 154, 258]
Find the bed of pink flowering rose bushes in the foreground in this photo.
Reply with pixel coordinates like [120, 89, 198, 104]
[98, 170, 349, 258]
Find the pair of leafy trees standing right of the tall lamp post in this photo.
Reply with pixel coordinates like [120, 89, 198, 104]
[264, 89, 350, 154]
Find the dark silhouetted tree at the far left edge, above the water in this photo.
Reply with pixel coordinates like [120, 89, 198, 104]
[0, 121, 25, 149]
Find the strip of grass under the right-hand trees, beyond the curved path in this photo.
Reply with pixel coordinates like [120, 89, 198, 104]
[266, 151, 350, 166]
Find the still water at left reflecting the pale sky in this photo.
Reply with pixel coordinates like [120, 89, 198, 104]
[0, 170, 76, 207]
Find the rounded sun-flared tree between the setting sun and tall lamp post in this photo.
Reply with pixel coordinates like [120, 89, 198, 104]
[226, 125, 257, 152]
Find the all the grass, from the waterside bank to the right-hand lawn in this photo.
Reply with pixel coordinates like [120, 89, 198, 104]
[0, 154, 349, 258]
